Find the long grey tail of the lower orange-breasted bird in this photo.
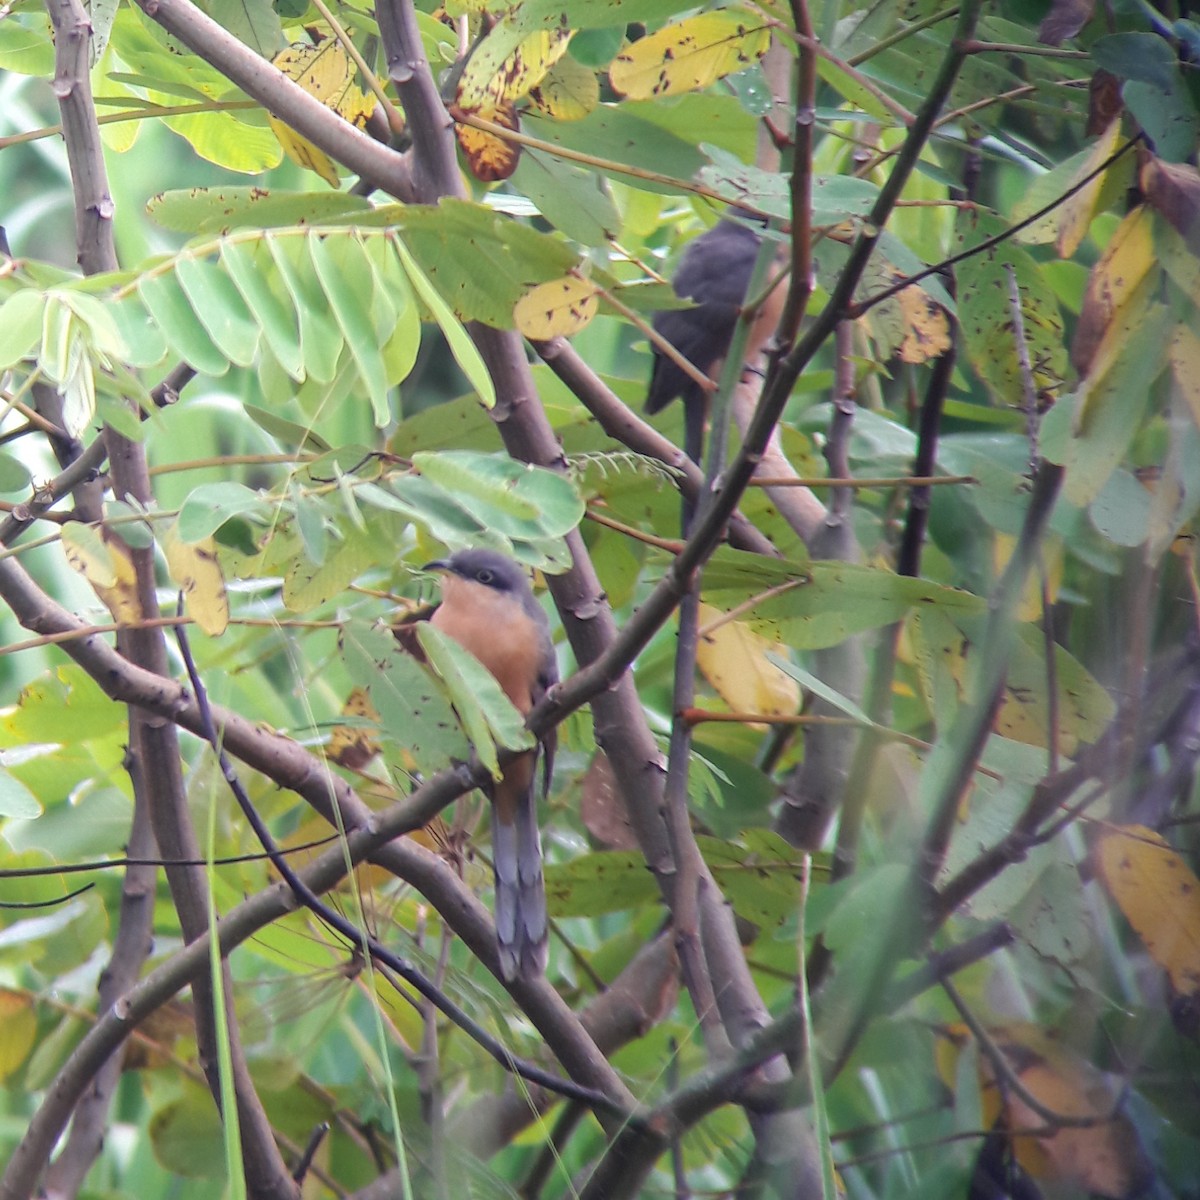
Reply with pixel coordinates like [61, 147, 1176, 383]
[492, 772, 548, 979]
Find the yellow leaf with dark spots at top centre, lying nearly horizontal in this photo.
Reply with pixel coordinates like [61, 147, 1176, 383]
[608, 8, 770, 100]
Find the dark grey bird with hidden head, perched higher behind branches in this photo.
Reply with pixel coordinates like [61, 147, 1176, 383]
[646, 217, 787, 462]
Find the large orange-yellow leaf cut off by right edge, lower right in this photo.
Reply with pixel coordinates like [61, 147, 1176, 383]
[1096, 826, 1200, 996]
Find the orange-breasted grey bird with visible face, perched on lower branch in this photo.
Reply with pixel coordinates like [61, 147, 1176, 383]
[425, 550, 558, 979]
